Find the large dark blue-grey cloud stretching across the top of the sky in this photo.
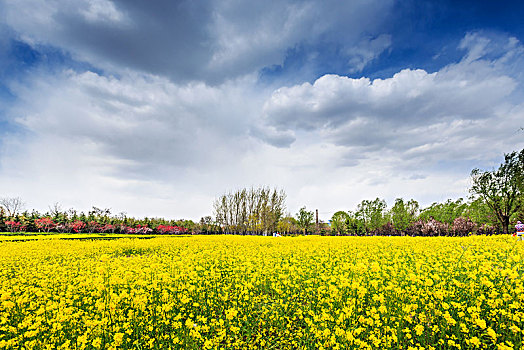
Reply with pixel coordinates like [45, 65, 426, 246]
[0, 0, 392, 84]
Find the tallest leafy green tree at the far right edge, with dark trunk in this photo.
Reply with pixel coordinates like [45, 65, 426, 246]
[470, 149, 524, 233]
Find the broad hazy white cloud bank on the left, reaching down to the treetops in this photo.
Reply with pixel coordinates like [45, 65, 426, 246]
[0, 71, 270, 219]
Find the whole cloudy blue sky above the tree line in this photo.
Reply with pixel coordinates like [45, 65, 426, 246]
[0, 0, 524, 221]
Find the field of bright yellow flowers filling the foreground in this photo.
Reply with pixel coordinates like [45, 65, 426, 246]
[0, 236, 524, 349]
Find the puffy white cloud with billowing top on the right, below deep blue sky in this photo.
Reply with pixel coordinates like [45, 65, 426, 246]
[263, 34, 524, 169]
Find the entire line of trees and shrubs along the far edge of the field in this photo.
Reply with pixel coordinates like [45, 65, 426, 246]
[0, 149, 524, 236]
